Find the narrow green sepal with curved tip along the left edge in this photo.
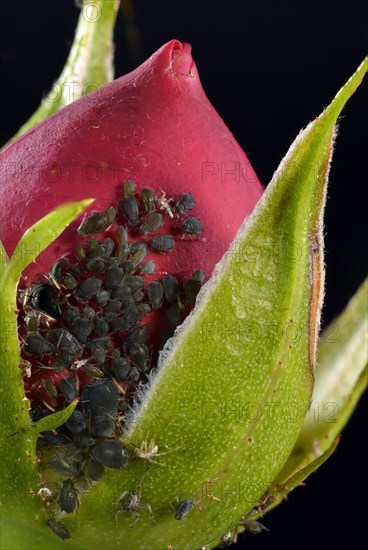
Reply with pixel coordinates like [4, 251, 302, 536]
[0, 199, 92, 524]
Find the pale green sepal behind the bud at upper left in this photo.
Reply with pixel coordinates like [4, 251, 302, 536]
[5, 0, 119, 147]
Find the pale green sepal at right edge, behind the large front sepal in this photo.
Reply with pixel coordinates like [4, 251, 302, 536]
[281, 279, 368, 479]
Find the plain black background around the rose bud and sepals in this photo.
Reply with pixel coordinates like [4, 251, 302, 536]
[0, 0, 368, 550]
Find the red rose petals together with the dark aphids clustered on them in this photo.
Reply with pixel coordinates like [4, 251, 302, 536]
[0, 40, 263, 511]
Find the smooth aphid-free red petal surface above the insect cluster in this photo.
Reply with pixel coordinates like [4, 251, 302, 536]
[0, 40, 263, 278]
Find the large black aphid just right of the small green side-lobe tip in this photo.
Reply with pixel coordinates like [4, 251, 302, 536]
[81, 380, 119, 416]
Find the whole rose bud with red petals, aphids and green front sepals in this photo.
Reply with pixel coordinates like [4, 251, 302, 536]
[0, 24, 366, 549]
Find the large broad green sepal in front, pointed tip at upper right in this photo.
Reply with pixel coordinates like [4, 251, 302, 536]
[55, 49, 367, 550]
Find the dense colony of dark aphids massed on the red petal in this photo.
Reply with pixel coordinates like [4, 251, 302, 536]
[19, 181, 205, 538]
